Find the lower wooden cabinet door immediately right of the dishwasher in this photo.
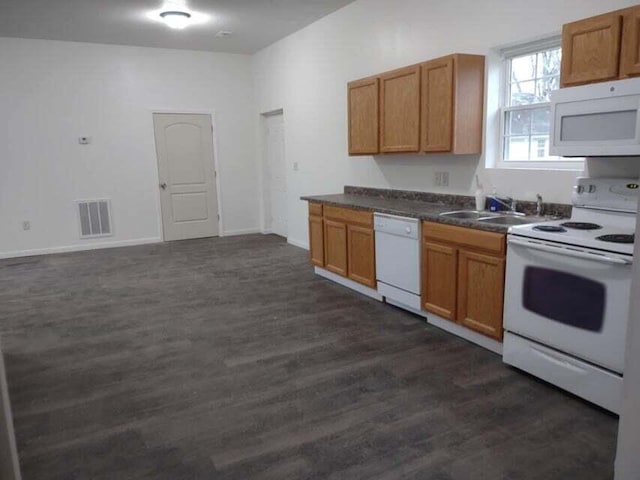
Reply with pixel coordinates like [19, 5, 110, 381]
[422, 240, 458, 321]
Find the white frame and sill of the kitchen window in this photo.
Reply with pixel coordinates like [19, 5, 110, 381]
[495, 35, 584, 171]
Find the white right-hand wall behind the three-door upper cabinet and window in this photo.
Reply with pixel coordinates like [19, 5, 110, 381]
[254, 0, 636, 248]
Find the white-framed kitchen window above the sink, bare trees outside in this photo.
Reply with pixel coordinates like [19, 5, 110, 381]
[499, 37, 582, 168]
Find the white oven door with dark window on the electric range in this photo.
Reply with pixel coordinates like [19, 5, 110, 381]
[504, 235, 631, 373]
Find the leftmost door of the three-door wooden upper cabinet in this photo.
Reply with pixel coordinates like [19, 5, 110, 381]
[347, 78, 379, 155]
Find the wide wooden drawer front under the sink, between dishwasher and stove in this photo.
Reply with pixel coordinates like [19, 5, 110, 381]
[422, 222, 506, 255]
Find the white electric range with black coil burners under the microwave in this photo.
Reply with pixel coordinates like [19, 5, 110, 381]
[503, 178, 639, 413]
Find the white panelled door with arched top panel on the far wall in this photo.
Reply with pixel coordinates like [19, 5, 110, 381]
[153, 113, 218, 241]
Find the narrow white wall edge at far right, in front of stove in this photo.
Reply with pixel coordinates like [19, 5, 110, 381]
[615, 204, 640, 480]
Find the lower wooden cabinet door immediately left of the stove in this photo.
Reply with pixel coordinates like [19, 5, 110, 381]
[458, 249, 505, 340]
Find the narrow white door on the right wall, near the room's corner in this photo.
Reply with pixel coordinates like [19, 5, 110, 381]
[264, 113, 288, 238]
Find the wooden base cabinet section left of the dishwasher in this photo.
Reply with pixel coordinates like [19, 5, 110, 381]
[309, 203, 376, 288]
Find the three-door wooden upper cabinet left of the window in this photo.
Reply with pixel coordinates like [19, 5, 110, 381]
[347, 54, 485, 155]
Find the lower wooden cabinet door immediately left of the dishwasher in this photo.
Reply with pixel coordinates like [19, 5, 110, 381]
[347, 225, 376, 288]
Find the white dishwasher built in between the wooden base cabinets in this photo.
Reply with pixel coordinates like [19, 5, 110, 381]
[373, 213, 425, 316]
